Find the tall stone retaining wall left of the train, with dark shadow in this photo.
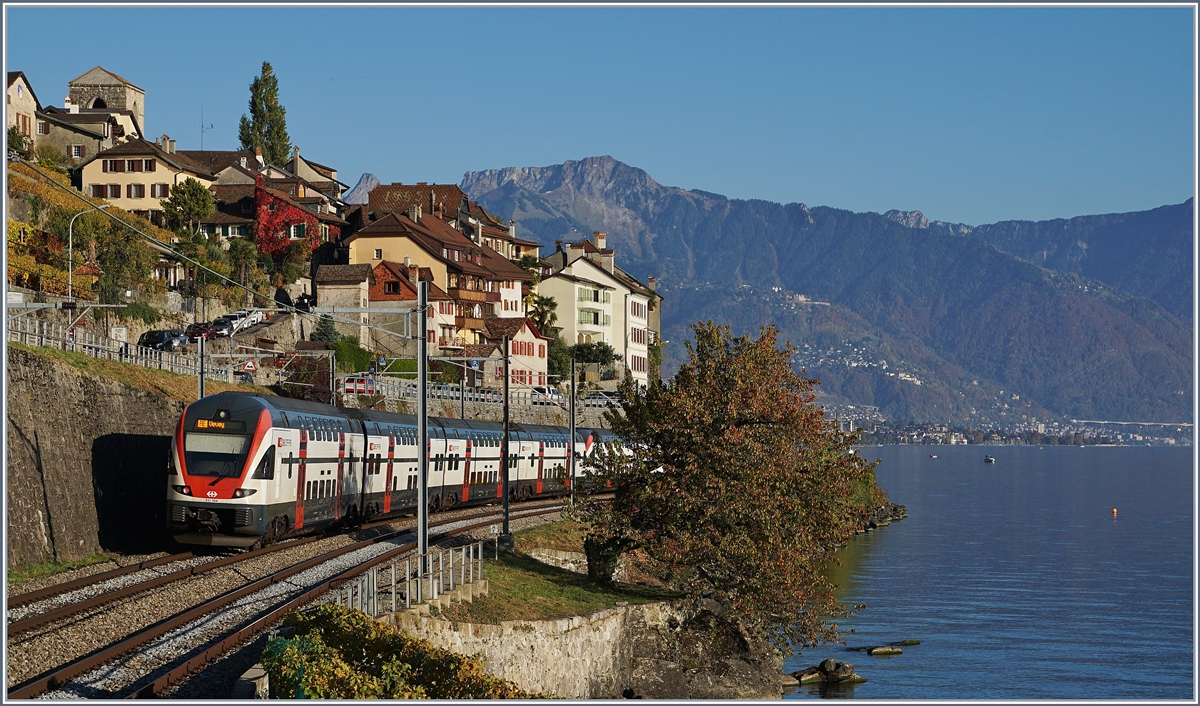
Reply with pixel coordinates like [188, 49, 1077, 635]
[6, 348, 184, 567]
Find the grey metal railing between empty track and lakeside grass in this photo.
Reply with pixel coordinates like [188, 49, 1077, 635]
[329, 542, 484, 617]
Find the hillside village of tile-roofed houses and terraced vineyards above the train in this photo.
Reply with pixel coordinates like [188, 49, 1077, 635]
[7, 66, 661, 389]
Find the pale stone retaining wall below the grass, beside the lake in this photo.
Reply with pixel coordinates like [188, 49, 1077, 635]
[382, 603, 686, 699]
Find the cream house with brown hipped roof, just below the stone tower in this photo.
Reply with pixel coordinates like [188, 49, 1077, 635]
[77, 134, 216, 226]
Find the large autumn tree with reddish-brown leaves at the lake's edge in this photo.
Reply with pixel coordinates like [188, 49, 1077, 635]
[581, 322, 884, 651]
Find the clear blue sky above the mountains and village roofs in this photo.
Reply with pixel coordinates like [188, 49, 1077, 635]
[5, 6, 1195, 225]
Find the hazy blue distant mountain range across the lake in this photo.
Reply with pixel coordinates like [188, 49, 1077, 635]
[461, 156, 1193, 424]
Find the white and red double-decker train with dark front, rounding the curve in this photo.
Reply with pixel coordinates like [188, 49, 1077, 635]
[167, 393, 606, 548]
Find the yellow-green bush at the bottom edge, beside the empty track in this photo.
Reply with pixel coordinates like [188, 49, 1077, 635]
[262, 603, 539, 699]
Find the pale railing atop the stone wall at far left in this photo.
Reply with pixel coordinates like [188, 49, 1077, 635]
[7, 317, 228, 381]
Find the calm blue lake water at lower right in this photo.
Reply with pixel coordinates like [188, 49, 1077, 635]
[784, 447, 1195, 700]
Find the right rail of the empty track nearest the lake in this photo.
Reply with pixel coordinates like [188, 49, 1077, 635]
[125, 508, 562, 699]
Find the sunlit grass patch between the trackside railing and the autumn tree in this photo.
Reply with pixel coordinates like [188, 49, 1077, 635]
[442, 521, 682, 624]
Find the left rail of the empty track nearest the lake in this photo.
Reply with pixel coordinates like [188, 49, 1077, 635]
[7, 507, 562, 699]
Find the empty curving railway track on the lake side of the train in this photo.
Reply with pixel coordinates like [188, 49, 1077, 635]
[7, 502, 563, 699]
